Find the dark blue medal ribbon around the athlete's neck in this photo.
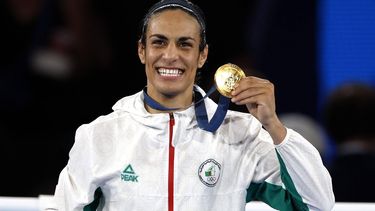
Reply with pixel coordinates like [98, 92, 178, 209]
[143, 85, 230, 132]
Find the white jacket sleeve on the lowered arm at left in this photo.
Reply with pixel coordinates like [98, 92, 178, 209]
[54, 125, 101, 211]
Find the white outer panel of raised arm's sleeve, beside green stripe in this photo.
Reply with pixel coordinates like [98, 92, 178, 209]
[276, 129, 335, 210]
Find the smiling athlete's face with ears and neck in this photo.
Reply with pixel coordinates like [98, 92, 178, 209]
[138, 8, 208, 111]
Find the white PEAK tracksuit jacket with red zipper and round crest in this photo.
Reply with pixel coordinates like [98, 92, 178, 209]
[54, 87, 334, 211]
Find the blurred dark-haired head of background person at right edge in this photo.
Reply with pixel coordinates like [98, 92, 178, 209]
[323, 82, 375, 144]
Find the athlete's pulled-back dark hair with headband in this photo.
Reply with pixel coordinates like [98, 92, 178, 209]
[139, 0, 207, 51]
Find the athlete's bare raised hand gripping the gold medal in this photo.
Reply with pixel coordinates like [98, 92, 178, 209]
[231, 76, 286, 144]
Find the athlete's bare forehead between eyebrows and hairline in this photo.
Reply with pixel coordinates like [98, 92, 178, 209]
[147, 9, 200, 37]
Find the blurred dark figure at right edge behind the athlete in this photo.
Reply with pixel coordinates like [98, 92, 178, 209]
[322, 81, 375, 202]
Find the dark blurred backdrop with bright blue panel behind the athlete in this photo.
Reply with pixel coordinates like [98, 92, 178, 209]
[0, 0, 375, 201]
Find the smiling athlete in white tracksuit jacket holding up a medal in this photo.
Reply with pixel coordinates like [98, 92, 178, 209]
[54, 0, 334, 211]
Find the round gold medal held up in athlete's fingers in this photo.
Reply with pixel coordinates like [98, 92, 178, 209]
[215, 63, 245, 98]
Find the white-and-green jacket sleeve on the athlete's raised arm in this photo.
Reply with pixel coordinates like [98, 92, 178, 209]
[246, 129, 335, 211]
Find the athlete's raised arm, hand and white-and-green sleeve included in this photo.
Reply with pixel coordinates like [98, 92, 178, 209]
[232, 77, 334, 210]
